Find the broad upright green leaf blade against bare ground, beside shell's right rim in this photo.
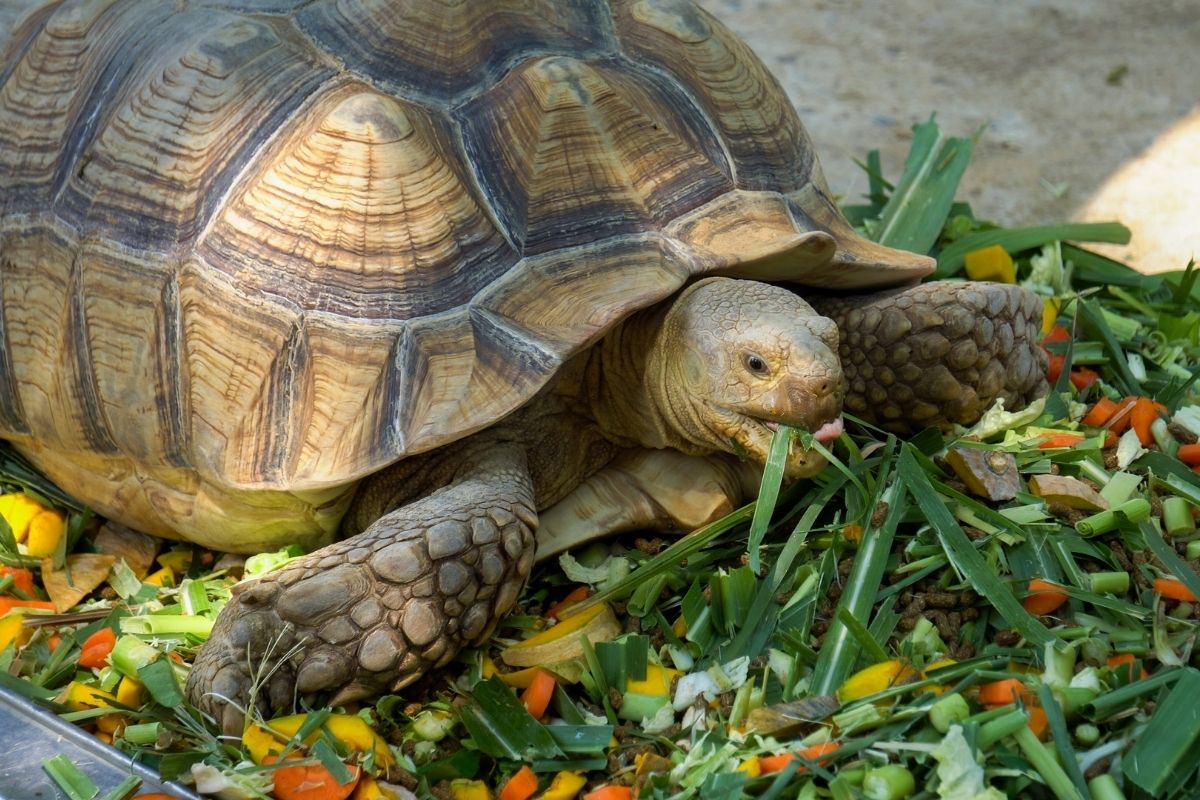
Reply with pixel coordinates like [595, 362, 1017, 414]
[872, 116, 974, 253]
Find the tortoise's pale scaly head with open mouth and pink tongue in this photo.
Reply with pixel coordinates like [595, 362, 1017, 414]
[648, 278, 846, 479]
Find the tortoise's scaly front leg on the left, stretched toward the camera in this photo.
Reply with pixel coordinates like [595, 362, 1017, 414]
[187, 446, 538, 735]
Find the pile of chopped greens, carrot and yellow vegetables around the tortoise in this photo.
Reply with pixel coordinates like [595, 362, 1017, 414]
[0, 122, 1200, 800]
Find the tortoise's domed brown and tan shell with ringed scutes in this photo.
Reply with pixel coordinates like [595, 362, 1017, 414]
[0, 0, 928, 549]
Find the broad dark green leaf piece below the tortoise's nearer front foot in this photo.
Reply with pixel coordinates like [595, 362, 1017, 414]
[458, 678, 563, 762]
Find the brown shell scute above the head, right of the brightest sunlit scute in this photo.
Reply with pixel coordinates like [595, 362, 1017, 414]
[462, 56, 733, 255]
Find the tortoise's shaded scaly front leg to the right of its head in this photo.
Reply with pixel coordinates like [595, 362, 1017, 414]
[805, 281, 1048, 433]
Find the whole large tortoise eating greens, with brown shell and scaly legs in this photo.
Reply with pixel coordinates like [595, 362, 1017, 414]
[0, 0, 1045, 733]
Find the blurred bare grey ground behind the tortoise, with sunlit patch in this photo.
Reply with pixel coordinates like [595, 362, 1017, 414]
[701, 0, 1200, 271]
